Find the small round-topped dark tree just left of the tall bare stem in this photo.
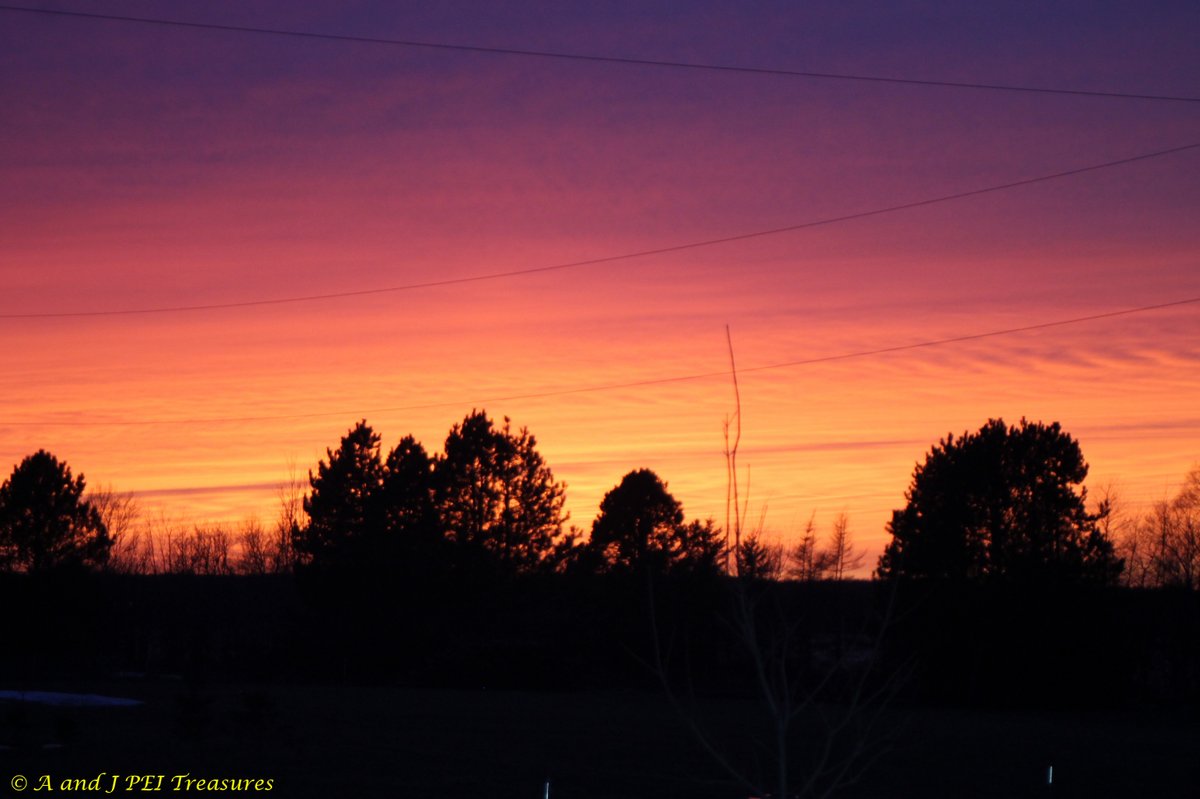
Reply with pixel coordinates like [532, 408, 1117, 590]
[589, 469, 722, 573]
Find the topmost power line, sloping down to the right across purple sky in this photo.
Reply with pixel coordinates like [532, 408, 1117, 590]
[0, 5, 1200, 103]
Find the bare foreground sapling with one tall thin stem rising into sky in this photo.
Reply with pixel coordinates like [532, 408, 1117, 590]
[649, 329, 899, 799]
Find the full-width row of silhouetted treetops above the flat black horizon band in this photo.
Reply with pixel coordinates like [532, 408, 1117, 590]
[0, 411, 1200, 590]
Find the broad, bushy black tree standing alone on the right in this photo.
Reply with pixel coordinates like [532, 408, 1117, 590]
[877, 419, 1122, 584]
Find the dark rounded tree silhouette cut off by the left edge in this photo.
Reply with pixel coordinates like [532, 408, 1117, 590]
[0, 450, 112, 572]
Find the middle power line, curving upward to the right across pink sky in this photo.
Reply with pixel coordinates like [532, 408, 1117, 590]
[0, 142, 1200, 319]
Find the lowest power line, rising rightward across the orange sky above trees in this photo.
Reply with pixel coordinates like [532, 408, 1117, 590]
[11, 296, 1200, 427]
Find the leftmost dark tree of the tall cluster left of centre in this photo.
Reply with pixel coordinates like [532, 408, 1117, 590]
[293, 420, 384, 566]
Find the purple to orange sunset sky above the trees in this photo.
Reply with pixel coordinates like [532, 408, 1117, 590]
[0, 0, 1200, 565]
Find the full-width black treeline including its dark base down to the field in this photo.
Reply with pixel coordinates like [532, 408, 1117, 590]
[7, 411, 1200, 704]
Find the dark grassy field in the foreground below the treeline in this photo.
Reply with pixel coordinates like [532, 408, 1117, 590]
[0, 679, 1200, 799]
